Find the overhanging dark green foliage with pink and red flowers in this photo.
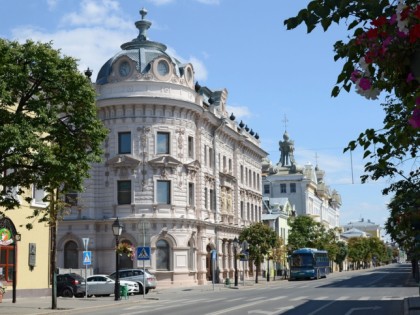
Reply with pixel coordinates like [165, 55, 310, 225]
[284, 0, 420, 264]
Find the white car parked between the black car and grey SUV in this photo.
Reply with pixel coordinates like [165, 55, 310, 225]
[86, 275, 140, 296]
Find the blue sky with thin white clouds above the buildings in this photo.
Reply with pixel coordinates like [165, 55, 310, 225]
[0, 0, 389, 237]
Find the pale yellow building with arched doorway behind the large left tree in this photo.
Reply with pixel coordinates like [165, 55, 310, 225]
[0, 189, 51, 298]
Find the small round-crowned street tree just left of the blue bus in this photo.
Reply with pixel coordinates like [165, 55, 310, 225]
[239, 222, 280, 283]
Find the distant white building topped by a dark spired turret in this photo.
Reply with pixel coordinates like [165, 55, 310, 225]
[263, 132, 341, 228]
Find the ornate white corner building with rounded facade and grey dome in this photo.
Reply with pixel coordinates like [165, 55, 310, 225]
[58, 9, 267, 286]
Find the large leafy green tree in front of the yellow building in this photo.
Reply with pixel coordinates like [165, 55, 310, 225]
[0, 39, 107, 309]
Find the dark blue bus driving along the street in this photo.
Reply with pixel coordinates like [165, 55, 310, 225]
[289, 248, 330, 281]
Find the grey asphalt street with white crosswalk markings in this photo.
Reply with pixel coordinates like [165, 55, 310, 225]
[61, 264, 419, 315]
